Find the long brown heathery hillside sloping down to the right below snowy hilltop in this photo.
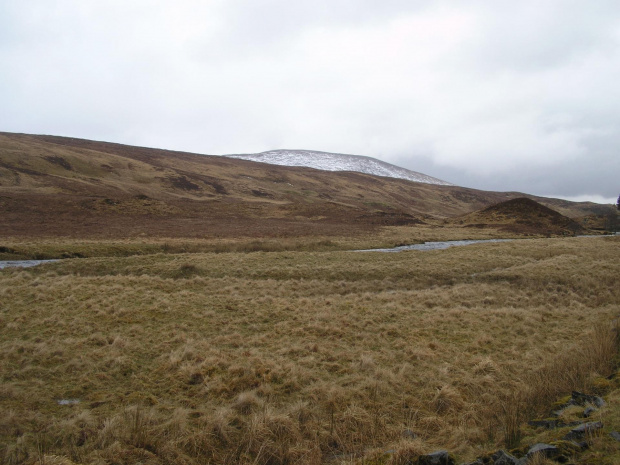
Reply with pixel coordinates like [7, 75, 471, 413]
[0, 133, 605, 237]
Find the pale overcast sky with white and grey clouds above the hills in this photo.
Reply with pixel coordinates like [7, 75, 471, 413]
[0, 0, 620, 203]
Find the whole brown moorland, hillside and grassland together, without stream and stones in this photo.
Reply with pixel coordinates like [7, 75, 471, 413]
[0, 134, 620, 465]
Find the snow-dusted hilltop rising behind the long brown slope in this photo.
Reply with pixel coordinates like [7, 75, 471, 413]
[228, 150, 452, 186]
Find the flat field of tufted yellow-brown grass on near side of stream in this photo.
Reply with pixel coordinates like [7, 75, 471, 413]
[0, 235, 620, 464]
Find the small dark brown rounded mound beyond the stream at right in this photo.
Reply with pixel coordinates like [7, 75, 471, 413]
[452, 197, 584, 235]
